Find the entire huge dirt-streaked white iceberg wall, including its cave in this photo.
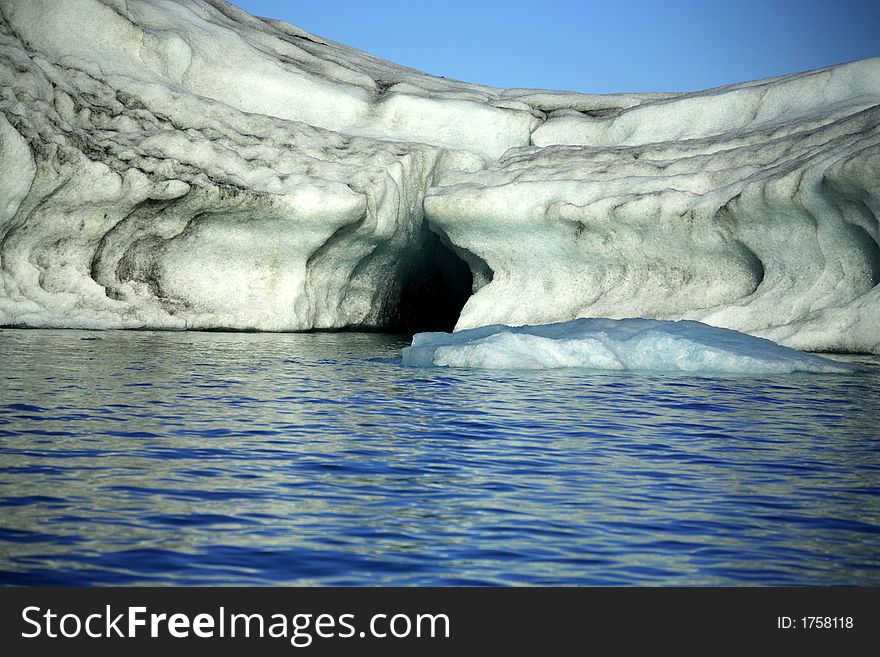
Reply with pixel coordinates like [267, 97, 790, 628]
[0, 0, 880, 352]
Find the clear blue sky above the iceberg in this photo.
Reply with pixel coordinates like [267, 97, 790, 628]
[234, 0, 880, 93]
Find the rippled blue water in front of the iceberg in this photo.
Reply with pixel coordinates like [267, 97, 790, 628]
[0, 330, 880, 585]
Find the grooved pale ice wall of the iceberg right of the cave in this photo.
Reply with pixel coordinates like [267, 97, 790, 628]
[425, 59, 880, 352]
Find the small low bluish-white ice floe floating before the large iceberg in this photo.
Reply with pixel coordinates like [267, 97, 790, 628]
[403, 319, 854, 374]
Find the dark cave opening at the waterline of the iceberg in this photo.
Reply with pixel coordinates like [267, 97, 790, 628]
[386, 231, 474, 333]
